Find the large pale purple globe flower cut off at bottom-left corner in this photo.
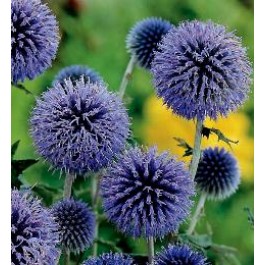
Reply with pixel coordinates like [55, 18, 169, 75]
[11, 189, 59, 265]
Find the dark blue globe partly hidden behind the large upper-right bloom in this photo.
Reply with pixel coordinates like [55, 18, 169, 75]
[126, 17, 172, 69]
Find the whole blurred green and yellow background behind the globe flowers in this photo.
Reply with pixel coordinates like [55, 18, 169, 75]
[12, 0, 254, 265]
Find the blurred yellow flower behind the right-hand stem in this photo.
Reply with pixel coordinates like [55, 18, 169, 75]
[141, 96, 254, 181]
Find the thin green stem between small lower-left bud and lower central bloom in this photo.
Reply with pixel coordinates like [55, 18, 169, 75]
[91, 174, 99, 257]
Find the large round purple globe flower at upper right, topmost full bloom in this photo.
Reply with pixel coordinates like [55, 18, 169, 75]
[151, 21, 251, 120]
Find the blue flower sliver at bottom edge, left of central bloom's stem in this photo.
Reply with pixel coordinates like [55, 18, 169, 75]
[83, 253, 133, 265]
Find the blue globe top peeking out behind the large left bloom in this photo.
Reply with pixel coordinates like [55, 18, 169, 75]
[52, 65, 103, 86]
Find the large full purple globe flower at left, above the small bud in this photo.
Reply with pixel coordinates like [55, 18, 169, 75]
[31, 78, 129, 175]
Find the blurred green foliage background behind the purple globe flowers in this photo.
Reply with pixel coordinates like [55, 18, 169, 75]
[12, 0, 254, 265]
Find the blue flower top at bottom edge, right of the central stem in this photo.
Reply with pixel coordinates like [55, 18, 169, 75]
[154, 245, 207, 265]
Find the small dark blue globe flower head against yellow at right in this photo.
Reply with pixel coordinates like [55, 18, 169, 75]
[195, 147, 240, 200]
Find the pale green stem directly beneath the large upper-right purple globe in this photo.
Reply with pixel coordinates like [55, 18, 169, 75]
[190, 120, 203, 179]
